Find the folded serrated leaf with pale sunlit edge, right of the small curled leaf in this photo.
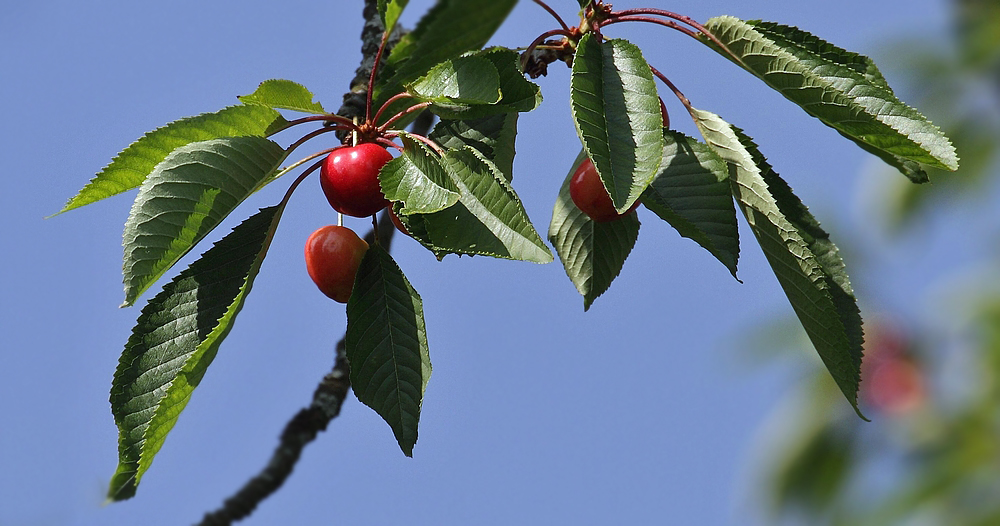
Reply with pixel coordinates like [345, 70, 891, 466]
[400, 146, 552, 263]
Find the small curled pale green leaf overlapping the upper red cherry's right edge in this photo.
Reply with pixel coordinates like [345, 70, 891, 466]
[379, 135, 458, 214]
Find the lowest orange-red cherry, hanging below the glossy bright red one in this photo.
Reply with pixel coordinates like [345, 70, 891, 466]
[306, 225, 368, 303]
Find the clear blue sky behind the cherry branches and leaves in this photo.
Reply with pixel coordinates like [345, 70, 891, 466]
[0, 0, 946, 526]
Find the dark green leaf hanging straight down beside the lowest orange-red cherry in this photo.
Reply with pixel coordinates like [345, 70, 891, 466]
[347, 244, 431, 457]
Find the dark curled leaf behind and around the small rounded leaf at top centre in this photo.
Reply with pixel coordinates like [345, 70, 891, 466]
[430, 47, 542, 119]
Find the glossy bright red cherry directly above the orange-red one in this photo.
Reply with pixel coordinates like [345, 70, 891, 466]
[319, 142, 392, 217]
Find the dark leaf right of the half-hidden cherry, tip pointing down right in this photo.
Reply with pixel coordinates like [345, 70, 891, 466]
[642, 130, 740, 277]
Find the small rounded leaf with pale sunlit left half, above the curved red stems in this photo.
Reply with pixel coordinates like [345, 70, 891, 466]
[407, 56, 500, 104]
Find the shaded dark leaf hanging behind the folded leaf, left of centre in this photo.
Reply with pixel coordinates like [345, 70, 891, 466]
[429, 113, 518, 182]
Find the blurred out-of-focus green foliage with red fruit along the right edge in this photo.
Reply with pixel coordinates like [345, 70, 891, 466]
[757, 0, 1000, 526]
